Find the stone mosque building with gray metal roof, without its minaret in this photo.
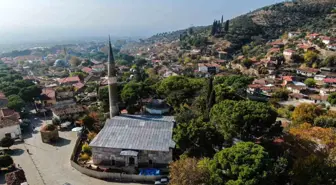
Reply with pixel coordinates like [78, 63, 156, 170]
[90, 115, 175, 168]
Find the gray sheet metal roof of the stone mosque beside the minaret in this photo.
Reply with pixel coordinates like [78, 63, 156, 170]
[90, 115, 175, 151]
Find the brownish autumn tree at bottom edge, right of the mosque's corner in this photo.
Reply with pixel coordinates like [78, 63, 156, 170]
[169, 158, 209, 185]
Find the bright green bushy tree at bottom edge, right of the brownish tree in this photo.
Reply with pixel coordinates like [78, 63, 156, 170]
[209, 142, 271, 185]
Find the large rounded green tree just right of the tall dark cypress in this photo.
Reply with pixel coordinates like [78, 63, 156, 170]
[210, 100, 282, 141]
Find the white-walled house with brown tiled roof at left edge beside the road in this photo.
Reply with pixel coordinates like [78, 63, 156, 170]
[0, 108, 22, 139]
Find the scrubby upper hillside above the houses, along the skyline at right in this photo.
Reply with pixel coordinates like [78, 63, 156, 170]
[123, 0, 336, 54]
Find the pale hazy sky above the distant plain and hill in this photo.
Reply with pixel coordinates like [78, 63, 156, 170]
[0, 0, 280, 43]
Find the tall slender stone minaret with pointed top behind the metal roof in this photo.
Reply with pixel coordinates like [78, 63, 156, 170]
[107, 37, 119, 119]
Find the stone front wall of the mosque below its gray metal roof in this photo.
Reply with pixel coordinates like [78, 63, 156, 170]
[92, 147, 173, 166]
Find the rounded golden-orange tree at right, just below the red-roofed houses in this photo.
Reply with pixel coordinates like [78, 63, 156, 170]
[292, 103, 324, 125]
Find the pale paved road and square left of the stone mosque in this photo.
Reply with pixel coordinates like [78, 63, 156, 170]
[0, 120, 141, 185]
